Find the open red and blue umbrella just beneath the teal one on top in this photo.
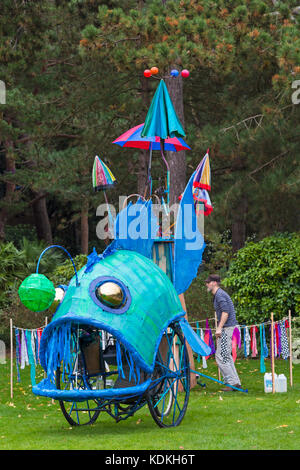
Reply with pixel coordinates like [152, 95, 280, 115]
[113, 123, 191, 152]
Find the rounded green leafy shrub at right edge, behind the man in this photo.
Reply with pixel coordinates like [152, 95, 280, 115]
[223, 233, 300, 323]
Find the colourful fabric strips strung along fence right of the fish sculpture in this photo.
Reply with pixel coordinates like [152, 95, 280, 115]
[193, 318, 290, 373]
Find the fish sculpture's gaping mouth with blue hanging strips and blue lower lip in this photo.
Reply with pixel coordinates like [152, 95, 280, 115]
[33, 322, 150, 401]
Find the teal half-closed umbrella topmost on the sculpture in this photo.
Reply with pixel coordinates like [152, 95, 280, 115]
[141, 80, 185, 139]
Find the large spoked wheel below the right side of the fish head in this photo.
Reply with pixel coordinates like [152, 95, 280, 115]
[147, 324, 190, 427]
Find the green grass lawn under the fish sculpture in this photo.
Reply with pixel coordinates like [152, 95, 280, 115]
[0, 359, 300, 450]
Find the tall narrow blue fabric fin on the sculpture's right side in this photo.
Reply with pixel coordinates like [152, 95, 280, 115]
[173, 172, 205, 294]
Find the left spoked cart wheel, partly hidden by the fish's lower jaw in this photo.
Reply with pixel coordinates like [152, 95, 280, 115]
[56, 369, 100, 426]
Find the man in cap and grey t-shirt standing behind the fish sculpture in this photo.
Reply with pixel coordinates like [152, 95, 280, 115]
[205, 274, 242, 392]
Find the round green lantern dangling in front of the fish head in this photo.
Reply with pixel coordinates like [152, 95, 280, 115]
[18, 273, 55, 312]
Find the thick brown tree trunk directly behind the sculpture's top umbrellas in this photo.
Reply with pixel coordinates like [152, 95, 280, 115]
[166, 76, 186, 205]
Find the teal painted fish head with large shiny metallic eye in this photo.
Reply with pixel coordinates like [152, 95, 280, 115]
[36, 250, 184, 372]
